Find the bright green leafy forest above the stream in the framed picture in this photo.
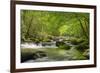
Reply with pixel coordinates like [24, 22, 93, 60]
[21, 10, 89, 42]
